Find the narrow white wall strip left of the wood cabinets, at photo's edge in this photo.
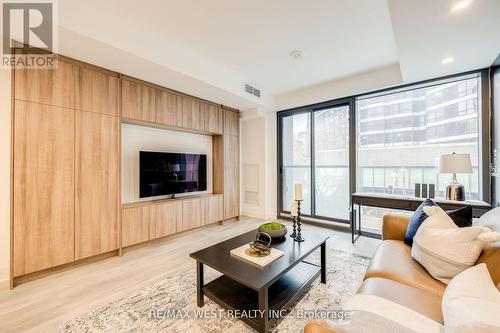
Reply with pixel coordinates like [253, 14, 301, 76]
[0, 69, 11, 289]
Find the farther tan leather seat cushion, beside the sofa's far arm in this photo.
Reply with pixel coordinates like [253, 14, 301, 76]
[364, 240, 446, 297]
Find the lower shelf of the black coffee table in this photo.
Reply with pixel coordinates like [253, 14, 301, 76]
[203, 261, 321, 330]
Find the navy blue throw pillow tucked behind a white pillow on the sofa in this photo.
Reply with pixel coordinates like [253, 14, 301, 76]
[404, 199, 472, 246]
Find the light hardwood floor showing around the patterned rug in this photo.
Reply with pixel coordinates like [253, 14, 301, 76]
[0, 217, 380, 332]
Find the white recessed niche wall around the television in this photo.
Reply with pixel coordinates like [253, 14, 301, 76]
[121, 124, 212, 203]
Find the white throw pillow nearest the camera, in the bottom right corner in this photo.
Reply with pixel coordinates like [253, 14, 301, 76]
[442, 264, 500, 333]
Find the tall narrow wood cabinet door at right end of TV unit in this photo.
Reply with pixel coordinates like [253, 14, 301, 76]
[224, 135, 240, 219]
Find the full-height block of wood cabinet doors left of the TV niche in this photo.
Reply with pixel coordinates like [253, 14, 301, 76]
[13, 58, 120, 276]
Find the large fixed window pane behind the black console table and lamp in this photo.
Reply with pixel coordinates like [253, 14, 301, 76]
[356, 75, 481, 232]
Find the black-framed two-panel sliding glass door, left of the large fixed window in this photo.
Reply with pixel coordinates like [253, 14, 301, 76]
[279, 100, 352, 222]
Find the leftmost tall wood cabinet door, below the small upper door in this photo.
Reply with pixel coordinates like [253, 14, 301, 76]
[13, 100, 75, 276]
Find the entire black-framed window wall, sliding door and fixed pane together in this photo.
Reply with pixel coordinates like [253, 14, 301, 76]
[278, 71, 489, 232]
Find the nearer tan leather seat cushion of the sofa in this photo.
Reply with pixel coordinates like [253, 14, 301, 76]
[359, 278, 443, 324]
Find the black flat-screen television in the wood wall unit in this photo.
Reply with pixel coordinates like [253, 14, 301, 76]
[139, 151, 207, 198]
